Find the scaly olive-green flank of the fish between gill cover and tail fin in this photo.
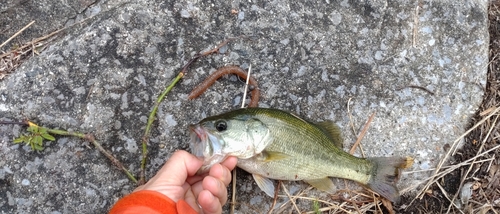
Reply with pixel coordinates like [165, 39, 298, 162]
[238, 109, 372, 183]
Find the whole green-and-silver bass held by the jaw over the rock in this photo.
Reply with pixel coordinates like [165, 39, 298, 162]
[189, 108, 413, 202]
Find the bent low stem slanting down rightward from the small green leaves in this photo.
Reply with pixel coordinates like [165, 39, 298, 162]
[47, 128, 137, 183]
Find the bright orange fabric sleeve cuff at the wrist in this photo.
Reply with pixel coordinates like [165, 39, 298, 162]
[109, 190, 197, 214]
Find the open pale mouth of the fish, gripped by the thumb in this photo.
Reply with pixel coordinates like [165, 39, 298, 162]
[189, 125, 222, 158]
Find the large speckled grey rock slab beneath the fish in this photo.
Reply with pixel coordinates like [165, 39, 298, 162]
[0, 0, 488, 214]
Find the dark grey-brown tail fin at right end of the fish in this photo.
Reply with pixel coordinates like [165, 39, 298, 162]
[366, 157, 413, 203]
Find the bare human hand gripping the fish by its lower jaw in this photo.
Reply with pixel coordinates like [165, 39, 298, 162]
[135, 150, 237, 214]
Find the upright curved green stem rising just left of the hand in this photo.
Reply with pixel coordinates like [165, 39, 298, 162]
[139, 72, 184, 185]
